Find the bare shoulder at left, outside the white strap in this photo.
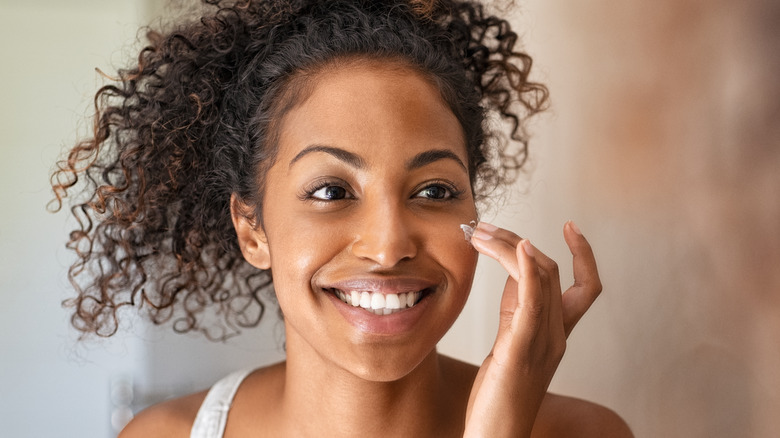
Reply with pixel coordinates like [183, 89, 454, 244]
[119, 391, 208, 438]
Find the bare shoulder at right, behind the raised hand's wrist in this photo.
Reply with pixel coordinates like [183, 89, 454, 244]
[533, 393, 634, 438]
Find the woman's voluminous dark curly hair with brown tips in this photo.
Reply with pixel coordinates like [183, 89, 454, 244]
[52, 0, 547, 339]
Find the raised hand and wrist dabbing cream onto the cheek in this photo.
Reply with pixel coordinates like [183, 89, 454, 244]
[464, 222, 601, 438]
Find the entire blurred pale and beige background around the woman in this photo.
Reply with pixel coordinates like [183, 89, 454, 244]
[0, 0, 780, 437]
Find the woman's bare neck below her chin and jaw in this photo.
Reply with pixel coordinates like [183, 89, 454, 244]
[282, 331, 465, 437]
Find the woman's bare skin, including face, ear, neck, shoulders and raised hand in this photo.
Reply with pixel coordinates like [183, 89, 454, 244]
[121, 62, 631, 437]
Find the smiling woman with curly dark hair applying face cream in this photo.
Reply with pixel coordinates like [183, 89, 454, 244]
[54, 0, 630, 437]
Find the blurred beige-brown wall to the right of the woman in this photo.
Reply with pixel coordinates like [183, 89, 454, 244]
[448, 0, 780, 437]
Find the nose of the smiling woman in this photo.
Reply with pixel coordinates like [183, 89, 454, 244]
[351, 199, 417, 268]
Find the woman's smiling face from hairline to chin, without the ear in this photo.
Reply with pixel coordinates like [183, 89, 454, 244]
[244, 62, 477, 380]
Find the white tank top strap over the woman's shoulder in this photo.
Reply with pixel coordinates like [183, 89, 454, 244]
[190, 369, 253, 438]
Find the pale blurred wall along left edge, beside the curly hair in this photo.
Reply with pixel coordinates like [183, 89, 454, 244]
[0, 0, 151, 438]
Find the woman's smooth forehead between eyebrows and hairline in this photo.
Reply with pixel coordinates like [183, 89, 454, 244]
[279, 61, 466, 162]
